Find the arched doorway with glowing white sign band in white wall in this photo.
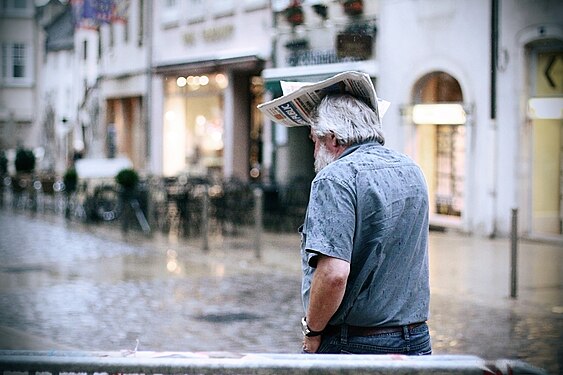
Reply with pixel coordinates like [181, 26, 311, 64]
[412, 71, 466, 225]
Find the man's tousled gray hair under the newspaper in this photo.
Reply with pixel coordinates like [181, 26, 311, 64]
[311, 94, 385, 146]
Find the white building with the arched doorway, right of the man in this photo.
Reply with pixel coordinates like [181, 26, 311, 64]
[377, 0, 563, 238]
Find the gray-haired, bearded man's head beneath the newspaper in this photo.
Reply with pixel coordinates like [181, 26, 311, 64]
[310, 94, 385, 172]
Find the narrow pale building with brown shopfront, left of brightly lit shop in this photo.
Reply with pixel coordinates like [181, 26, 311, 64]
[94, 0, 151, 171]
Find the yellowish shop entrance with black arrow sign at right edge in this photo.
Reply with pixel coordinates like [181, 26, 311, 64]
[523, 43, 563, 237]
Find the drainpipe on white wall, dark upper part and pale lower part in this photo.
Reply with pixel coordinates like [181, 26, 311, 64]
[490, 0, 500, 238]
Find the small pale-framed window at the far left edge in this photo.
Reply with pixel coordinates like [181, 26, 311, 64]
[0, 43, 31, 83]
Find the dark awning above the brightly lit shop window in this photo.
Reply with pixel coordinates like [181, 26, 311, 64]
[154, 54, 265, 74]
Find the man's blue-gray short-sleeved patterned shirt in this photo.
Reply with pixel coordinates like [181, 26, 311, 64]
[300, 142, 430, 327]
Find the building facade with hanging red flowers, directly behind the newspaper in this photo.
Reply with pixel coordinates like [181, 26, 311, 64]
[262, 0, 379, 185]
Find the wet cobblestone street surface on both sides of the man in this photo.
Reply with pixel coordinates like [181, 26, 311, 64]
[0, 208, 563, 374]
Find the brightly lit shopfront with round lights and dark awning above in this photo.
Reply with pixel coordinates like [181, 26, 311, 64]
[157, 57, 262, 181]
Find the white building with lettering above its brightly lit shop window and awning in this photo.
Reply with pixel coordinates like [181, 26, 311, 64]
[150, 0, 271, 180]
